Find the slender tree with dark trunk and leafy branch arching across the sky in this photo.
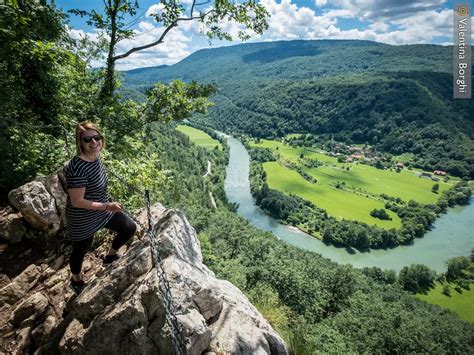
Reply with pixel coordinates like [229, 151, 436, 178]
[71, 0, 269, 98]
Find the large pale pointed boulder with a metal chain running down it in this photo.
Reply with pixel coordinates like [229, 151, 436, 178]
[41, 205, 288, 354]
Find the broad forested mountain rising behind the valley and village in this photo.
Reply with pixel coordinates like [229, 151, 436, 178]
[124, 40, 474, 178]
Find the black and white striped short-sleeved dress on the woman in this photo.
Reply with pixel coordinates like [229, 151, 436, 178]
[64, 156, 112, 241]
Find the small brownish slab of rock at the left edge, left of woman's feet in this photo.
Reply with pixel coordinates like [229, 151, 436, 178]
[0, 264, 41, 307]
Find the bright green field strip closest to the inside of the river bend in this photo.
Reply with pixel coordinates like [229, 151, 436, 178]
[263, 162, 401, 229]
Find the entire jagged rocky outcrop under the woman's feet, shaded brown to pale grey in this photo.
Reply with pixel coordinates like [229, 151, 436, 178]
[0, 196, 287, 354]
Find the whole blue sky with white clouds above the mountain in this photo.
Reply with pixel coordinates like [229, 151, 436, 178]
[54, 0, 466, 70]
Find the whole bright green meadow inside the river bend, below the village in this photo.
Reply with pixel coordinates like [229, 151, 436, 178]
[251, 139, 451, 229]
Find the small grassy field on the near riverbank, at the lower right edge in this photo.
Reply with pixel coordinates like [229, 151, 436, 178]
[416, 283, 474, 323]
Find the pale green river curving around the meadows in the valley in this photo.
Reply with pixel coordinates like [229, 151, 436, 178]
[225, 137, 474, 272]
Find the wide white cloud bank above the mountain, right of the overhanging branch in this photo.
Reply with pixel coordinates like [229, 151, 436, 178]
[254, 0, 452, 45]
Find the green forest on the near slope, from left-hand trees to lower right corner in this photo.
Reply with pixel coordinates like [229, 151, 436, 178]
[0, 1, 474, 354]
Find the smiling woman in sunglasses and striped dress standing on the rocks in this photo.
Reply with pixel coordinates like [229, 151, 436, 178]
[64, 122, 136, 294]
